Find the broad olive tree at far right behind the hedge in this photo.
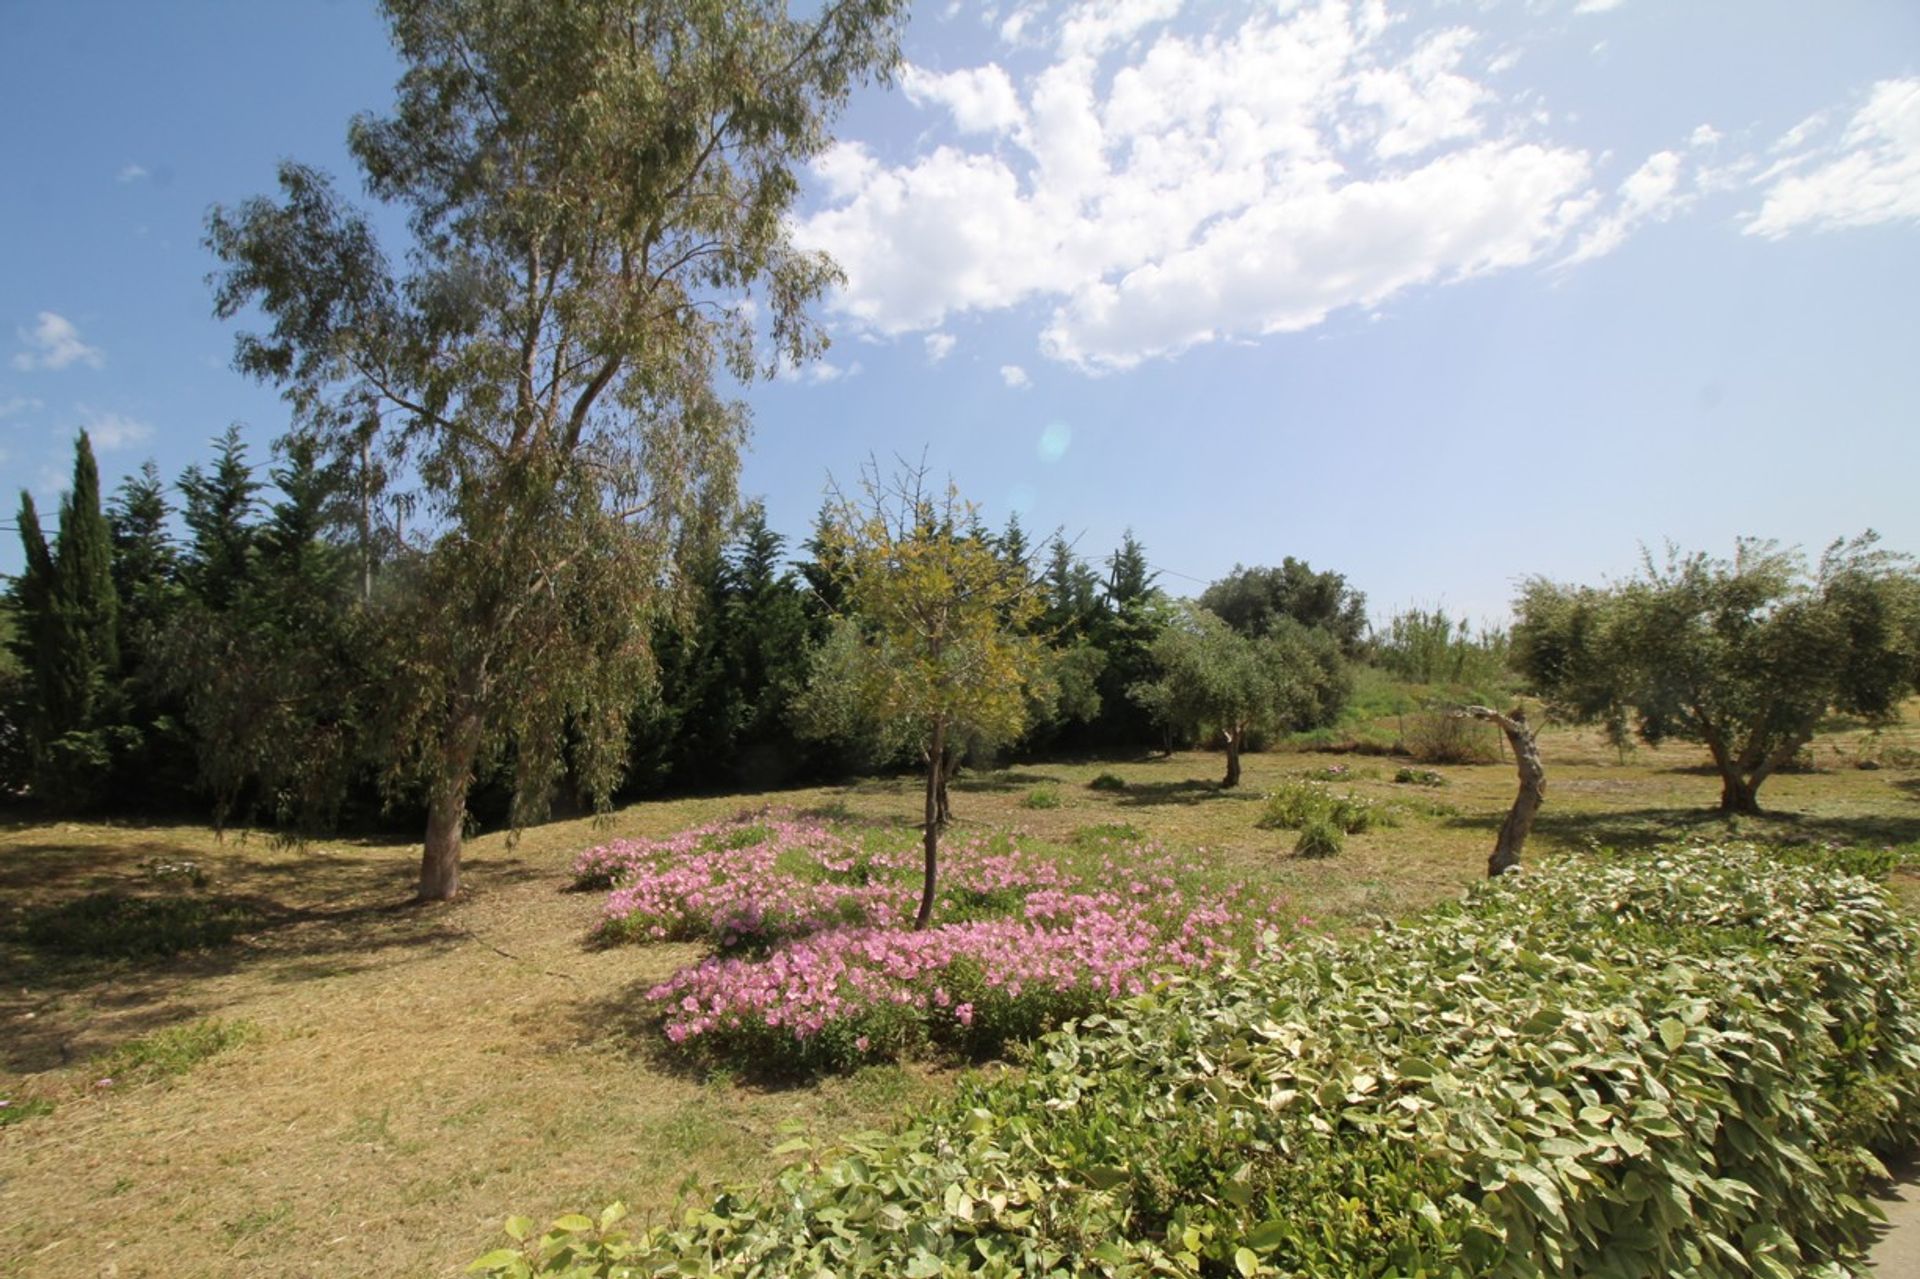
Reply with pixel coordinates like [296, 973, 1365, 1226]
[1513, 534, 1920, 812]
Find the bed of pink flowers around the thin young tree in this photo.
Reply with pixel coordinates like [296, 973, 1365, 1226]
[574, 812, 1290, 1068]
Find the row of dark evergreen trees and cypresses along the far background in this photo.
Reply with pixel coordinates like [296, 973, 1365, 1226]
[0, 430, 1503, 828]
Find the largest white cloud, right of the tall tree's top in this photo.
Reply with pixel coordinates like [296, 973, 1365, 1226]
[795, 0, 1620, 373]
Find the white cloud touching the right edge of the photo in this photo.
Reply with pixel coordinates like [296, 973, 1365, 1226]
[1745, 79, 1920, 238]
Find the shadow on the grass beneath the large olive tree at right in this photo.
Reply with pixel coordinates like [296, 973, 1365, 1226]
[1497, 808, 1920, 851]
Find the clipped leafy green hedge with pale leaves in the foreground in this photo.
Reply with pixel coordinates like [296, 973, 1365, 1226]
[474, 849, 1920, 1279]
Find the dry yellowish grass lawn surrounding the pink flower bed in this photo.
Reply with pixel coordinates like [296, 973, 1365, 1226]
[0, 706, 1920, 1277]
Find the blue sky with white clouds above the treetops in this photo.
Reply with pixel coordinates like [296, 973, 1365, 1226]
[0, 0, 1920, 618]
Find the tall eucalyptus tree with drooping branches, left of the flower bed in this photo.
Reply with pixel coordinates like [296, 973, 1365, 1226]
[207, 0, 904, 899]
